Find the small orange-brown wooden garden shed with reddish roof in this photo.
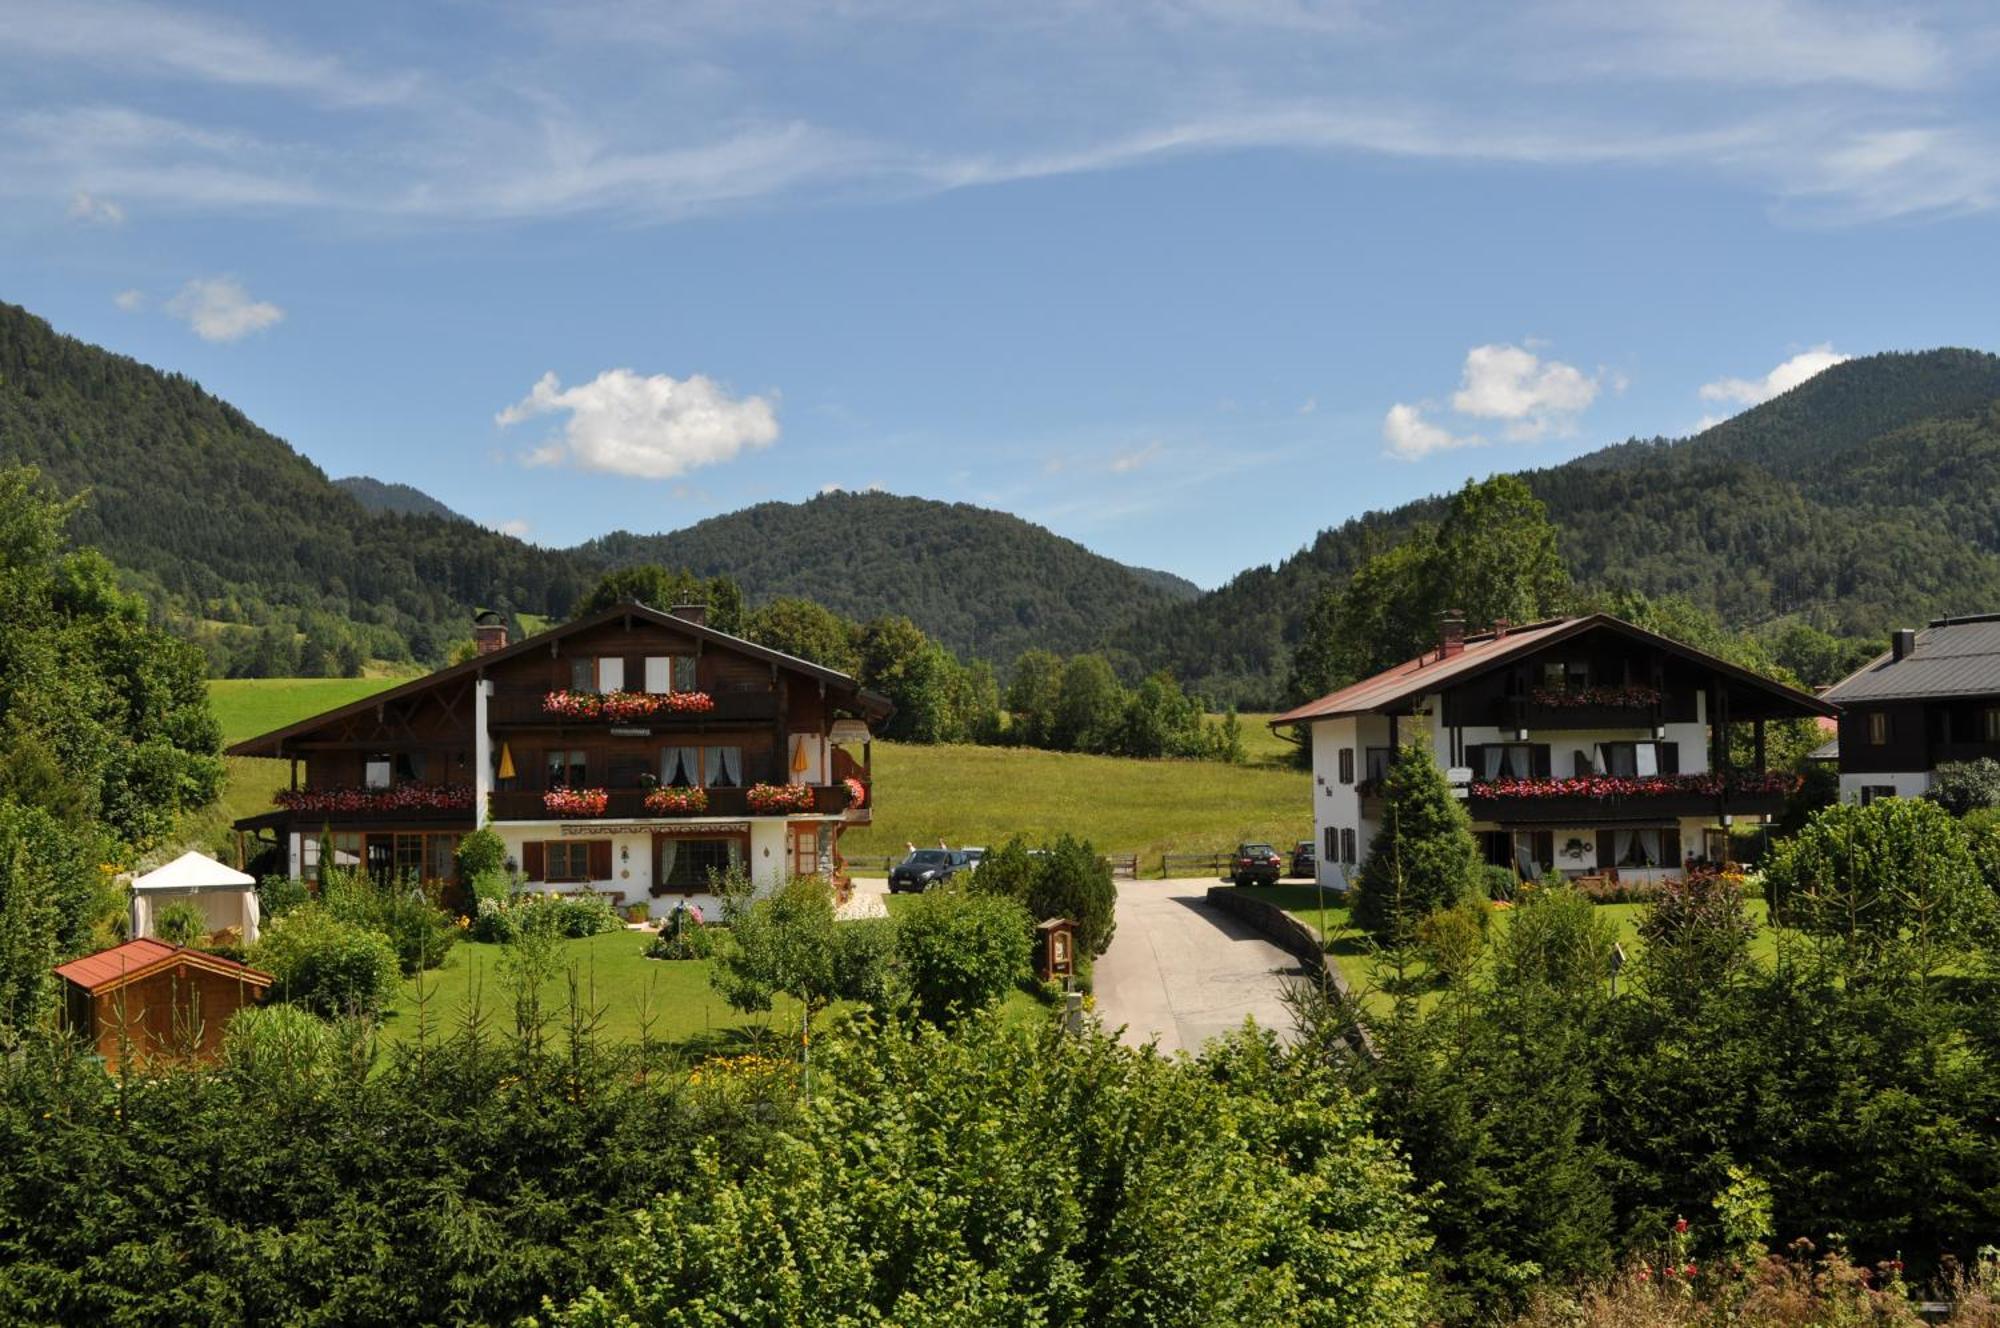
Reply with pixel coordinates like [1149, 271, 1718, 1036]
[56, 940, 272, 1068]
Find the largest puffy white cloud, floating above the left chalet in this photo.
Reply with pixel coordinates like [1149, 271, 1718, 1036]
[494, 368, 778, 480]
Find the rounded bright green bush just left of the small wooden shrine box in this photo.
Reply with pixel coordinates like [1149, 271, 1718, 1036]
[896, 892, 1034, 1026]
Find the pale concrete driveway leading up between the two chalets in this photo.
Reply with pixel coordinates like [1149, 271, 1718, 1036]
[1094, 880, 1298, 1052]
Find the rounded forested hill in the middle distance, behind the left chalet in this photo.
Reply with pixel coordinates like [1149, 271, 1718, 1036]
[576, 492, 1200, 662]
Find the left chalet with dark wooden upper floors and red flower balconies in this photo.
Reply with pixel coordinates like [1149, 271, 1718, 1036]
[230, 602, 892, 912]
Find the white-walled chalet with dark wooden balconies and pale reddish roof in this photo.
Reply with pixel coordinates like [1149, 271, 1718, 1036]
[1270, 614, 1832, 886]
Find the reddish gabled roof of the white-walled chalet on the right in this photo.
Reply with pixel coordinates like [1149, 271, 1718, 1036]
[1270, 614, 1834, 728]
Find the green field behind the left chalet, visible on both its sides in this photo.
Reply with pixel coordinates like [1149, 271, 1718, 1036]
[192, 678, 1312, 874]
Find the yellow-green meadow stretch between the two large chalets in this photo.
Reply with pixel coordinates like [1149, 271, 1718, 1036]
[840, 742, 1312, 874]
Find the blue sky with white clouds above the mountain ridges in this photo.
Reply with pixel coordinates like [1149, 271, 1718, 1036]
[0, 0, 2000, 584]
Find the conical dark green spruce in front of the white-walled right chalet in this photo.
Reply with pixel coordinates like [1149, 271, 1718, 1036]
[1354, 742, 1480, 942]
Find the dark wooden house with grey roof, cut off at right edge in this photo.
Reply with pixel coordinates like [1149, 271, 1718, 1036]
[1826, 614, 2000, 802]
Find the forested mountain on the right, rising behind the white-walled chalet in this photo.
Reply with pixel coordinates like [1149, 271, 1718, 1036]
[1112, 350, 2000, 706]
